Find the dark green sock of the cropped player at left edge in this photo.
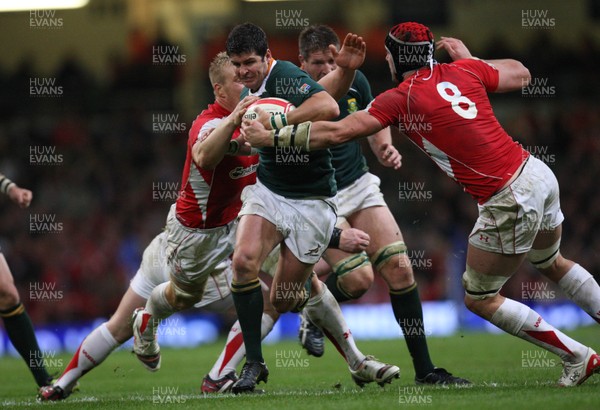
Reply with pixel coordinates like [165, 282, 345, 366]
[0, 303, 50, 387]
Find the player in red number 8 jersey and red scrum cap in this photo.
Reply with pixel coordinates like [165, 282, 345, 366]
[243, 22, 600, 386]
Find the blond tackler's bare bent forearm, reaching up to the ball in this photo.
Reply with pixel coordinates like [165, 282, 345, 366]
[192, 96, 258, 169]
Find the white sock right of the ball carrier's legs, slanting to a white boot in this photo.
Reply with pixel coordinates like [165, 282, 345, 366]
[304, 282, 366, 370]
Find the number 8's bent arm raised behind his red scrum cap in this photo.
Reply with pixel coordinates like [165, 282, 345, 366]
[436, 37, 531, 93]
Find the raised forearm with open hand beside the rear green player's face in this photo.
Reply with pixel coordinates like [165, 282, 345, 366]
[319, 33, 367, 101]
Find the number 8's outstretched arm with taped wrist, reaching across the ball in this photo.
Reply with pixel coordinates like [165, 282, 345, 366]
[242, 109, 382, 151]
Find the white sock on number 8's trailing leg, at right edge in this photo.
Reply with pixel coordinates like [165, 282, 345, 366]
[558, 264, 600, 323]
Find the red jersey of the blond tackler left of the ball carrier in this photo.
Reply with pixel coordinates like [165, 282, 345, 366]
[176, 103, 258, 229]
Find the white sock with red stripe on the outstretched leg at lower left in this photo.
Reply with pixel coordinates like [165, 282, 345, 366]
[55, 323, 120, 392]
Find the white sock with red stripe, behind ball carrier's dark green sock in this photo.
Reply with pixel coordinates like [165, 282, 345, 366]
[208, 313, 275, 380]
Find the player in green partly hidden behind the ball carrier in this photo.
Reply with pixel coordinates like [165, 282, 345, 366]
[298, 25, 469, 385]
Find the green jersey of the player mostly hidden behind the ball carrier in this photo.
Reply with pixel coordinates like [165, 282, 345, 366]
[330, 71, 373, 190]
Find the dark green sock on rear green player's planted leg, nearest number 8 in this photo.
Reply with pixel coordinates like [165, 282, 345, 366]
[390, 283, 434, 378]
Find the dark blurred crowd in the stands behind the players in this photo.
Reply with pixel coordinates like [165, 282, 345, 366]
[0, 0, 600, 324]
